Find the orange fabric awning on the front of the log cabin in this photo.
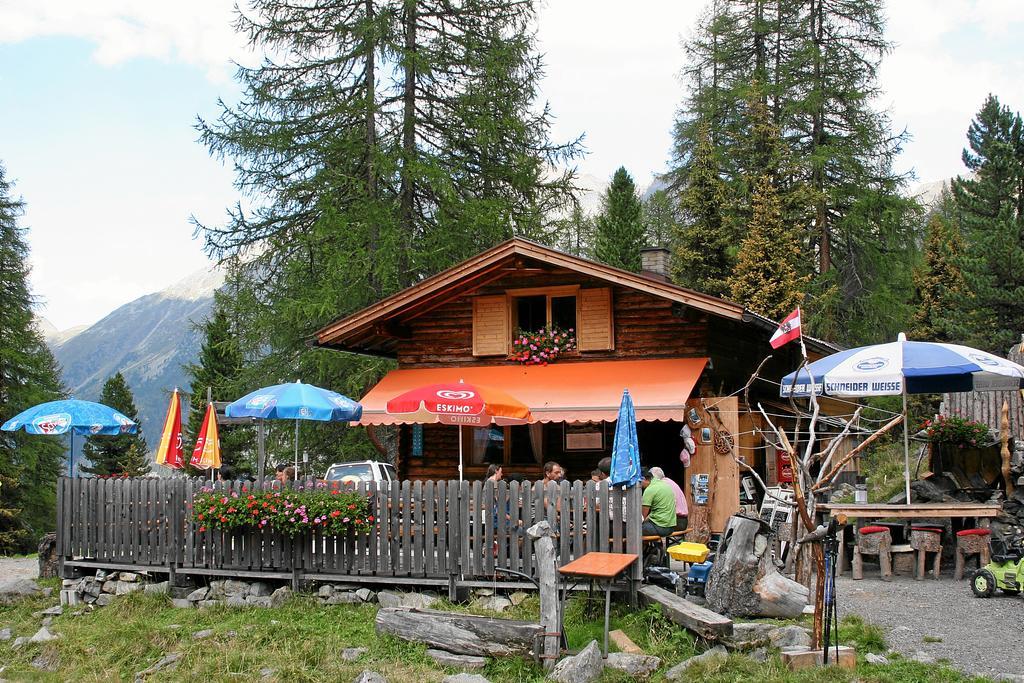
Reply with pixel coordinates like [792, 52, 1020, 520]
[358, 358, 708, 425]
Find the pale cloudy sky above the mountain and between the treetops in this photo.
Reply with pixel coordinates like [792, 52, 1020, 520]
[0, 0, 1024, 330]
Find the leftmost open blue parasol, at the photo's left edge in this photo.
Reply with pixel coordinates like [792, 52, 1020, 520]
[0, 398, 138, 476]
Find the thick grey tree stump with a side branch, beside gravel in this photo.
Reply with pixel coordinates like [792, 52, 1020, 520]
[705, 515, 810, 617]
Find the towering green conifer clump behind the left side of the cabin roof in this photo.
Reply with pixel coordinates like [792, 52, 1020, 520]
[191, 0, 580, 473]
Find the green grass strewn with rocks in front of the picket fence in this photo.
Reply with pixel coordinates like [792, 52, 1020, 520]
[0, 581, 980, 683]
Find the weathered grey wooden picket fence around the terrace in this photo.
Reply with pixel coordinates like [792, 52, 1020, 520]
[57, 477, 641, 592]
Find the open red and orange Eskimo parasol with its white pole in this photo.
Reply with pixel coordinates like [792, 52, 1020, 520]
[385, 381, 532, 480]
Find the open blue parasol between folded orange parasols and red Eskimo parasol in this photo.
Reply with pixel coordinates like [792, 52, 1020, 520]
[224, 382, 362, 475]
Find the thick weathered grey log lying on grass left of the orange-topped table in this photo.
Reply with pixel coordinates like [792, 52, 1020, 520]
[376, 607, 543, 657]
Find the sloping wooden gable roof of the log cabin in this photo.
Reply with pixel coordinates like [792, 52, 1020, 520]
[313, 238, 840, 358]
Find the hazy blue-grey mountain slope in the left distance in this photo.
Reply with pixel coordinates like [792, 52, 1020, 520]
[47, 267, 223, 449]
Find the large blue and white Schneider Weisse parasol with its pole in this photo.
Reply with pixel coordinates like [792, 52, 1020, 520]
[779, 333, 1024, 503]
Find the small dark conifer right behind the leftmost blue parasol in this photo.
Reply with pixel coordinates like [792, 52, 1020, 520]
[82, 373, 150, 476]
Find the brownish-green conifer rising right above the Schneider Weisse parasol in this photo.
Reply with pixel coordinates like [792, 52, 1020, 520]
[909, 212, 974, 342]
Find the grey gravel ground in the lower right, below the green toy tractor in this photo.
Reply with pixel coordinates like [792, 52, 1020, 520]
[836, 570, 1024, 676]
